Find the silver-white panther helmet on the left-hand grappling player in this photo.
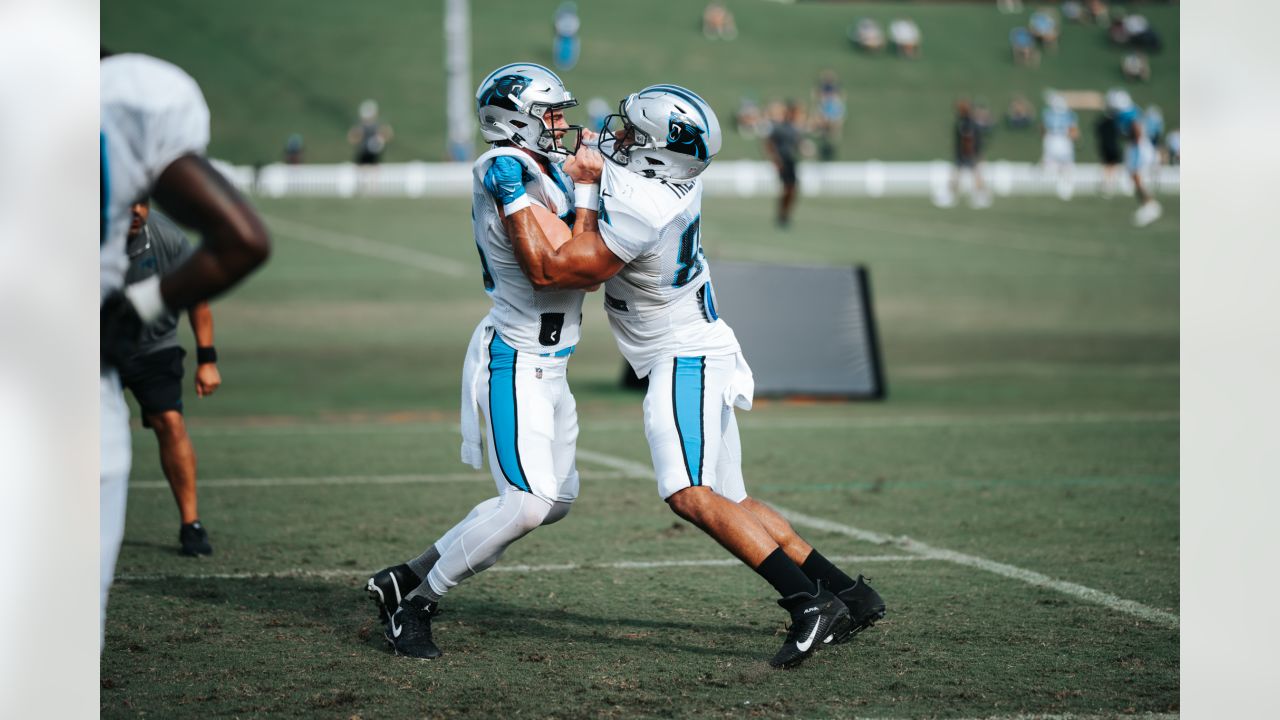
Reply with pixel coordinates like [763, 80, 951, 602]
[476, 63, 581, 160]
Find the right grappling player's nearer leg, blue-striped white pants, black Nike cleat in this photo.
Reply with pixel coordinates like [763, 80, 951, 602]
[644, 356, 849, 667]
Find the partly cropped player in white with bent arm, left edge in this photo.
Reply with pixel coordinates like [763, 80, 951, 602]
[99, 53, 270, 647]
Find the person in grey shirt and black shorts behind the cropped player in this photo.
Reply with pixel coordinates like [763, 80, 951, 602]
[118, 200, 223, 556]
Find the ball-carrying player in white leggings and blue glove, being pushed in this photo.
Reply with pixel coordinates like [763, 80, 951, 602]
[366, 63, 596, 659]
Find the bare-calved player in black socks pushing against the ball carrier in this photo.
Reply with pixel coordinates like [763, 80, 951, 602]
[513, 85, 884, 667]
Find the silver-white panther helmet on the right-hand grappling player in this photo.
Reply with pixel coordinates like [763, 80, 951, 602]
[600, 85, 722, 181]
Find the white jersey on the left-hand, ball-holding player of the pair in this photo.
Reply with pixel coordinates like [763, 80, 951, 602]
[471, 147, 586, 355]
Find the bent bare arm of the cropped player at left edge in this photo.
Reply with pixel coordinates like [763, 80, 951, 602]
[152, 155, 271, 309]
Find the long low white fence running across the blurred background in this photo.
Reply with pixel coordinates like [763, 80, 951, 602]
[214, 160, 1179, 197]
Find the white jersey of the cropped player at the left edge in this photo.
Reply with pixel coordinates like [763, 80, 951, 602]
[99, 55, 209, 297]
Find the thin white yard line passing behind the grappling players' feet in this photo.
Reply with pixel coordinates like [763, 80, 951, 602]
[115, 555, 932, 582]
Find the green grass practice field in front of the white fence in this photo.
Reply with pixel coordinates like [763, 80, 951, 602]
[101, 193, 1179, 717]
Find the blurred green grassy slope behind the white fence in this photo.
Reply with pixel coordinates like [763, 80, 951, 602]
[101, 0, 1179, 164]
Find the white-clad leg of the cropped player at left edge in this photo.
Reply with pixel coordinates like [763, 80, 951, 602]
[99, 370, 132, 652]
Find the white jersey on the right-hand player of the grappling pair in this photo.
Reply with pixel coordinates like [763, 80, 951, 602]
[599, 161, 740, 378]
